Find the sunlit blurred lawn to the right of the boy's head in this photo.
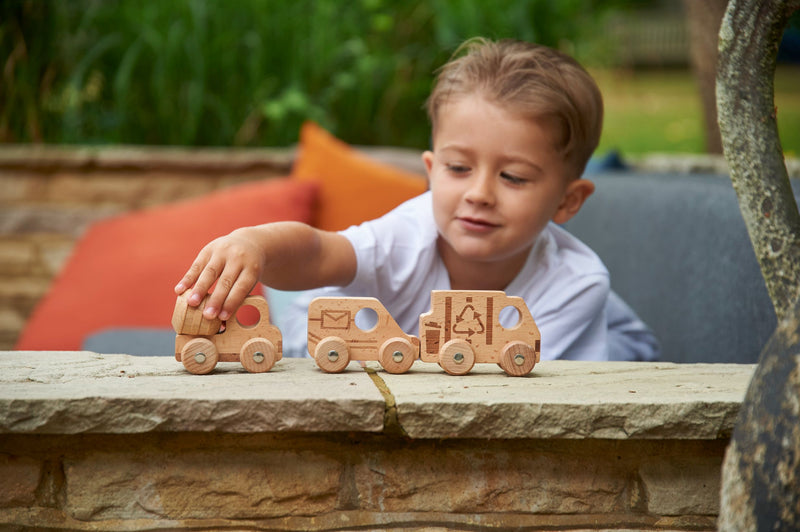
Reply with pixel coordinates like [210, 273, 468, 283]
[593, 65, 800, 157]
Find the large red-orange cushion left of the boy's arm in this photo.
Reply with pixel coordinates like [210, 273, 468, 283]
[16, 178, 317, 354]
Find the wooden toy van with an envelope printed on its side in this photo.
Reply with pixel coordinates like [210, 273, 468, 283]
[308, 297, 419, 373]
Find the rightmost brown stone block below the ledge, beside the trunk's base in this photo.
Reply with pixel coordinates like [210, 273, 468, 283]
[639, 456, 722, 515]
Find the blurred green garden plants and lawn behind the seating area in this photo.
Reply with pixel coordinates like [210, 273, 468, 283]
[0, 0, 800, 156]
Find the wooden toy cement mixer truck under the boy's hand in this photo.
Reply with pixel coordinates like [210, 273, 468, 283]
[172, 292, 283, 375]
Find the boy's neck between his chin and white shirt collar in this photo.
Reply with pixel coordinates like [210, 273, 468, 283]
[438, 239, 528, 290]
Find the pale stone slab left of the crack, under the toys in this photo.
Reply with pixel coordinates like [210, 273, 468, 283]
[0, 351, 385, 434]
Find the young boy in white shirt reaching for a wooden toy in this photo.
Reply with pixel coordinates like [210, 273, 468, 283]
[176, 39, 652, 360]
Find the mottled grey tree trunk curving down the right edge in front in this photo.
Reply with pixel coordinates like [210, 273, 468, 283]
[717, 0, 800, 532]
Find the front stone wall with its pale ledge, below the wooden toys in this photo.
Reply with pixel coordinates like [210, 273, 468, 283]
[0, 352, 754, 531]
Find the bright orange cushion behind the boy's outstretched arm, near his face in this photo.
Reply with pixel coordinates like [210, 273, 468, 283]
[292, 122, 427, 231]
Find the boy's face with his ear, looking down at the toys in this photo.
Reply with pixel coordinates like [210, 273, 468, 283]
[423, 95, 594, 274]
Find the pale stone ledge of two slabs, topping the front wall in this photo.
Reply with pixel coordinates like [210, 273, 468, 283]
[0, 352, 755, 440]
